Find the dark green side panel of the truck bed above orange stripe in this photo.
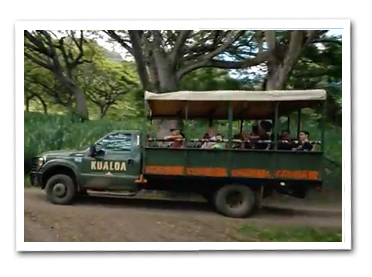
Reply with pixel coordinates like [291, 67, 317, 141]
[146, 148, 322, 179]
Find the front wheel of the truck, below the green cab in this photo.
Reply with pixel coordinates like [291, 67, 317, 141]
[45, 174, 76, 205]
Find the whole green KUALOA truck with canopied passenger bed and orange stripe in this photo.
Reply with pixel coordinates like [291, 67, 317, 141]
[30, 90, 326, 217]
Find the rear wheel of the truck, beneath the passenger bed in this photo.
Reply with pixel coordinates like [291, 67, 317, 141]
[214, 185, 255, 218]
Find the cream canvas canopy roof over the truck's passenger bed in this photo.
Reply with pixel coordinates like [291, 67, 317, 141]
[145, 90, 327, 120]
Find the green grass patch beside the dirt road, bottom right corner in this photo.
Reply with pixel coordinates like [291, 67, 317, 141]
[238, 225, 342, 242]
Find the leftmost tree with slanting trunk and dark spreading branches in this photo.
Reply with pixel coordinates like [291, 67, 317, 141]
[24, 30, 93, 120]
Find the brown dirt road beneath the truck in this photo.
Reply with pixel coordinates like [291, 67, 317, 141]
[24, 188, 342, 242]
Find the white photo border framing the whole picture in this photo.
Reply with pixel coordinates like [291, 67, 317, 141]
[15, 19, 352, 252]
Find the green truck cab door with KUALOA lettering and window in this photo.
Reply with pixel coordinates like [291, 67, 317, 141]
[82, 131, 141, 190]
